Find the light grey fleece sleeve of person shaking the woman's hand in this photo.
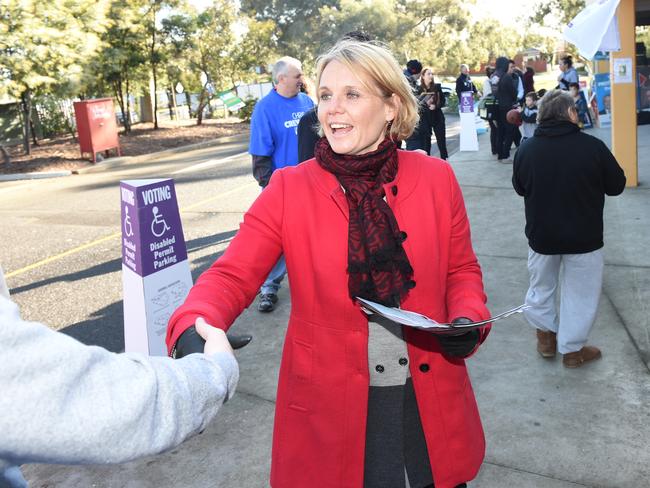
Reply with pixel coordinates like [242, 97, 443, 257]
[0, 297, 239, 464]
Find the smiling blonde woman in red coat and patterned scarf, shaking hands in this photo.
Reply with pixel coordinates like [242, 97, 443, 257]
[167, 40, 489, 488]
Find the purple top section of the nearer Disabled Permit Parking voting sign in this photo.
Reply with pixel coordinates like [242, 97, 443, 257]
[120, 179, 187, 277]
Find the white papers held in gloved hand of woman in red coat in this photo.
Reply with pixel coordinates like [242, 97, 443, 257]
[357, 297, 530, 334]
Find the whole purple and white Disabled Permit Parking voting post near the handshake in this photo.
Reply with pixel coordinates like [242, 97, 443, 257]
[120, 179, 192, 356]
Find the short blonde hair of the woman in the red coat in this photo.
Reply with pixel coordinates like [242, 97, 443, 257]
[316, 39, 419, 140]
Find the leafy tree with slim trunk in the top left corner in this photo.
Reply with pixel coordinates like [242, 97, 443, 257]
[0, 0, 108, 154]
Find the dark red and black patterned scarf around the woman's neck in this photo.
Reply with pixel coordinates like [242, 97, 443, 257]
[314, 137, 415, 307]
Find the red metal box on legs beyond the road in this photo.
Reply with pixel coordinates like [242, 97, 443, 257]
[74, 98, 122, 163]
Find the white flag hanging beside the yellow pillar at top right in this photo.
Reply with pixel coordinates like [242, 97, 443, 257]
[564, 0, 621, 59]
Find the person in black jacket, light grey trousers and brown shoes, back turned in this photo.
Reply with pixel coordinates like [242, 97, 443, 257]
[512, 90, 625, 368]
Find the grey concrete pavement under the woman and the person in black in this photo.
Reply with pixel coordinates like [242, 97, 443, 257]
[17, 126, 650, 488]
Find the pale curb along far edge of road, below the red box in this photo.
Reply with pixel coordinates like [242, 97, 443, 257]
[0, 132, 248, 181]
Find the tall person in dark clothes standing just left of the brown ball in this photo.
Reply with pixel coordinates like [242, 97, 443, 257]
[494, 56, 517, 163]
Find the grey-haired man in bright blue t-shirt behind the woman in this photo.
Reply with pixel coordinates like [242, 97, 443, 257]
[248, 56, 314, 312]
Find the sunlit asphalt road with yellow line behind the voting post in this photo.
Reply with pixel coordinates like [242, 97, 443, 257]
[0, 136, 259, 351]
